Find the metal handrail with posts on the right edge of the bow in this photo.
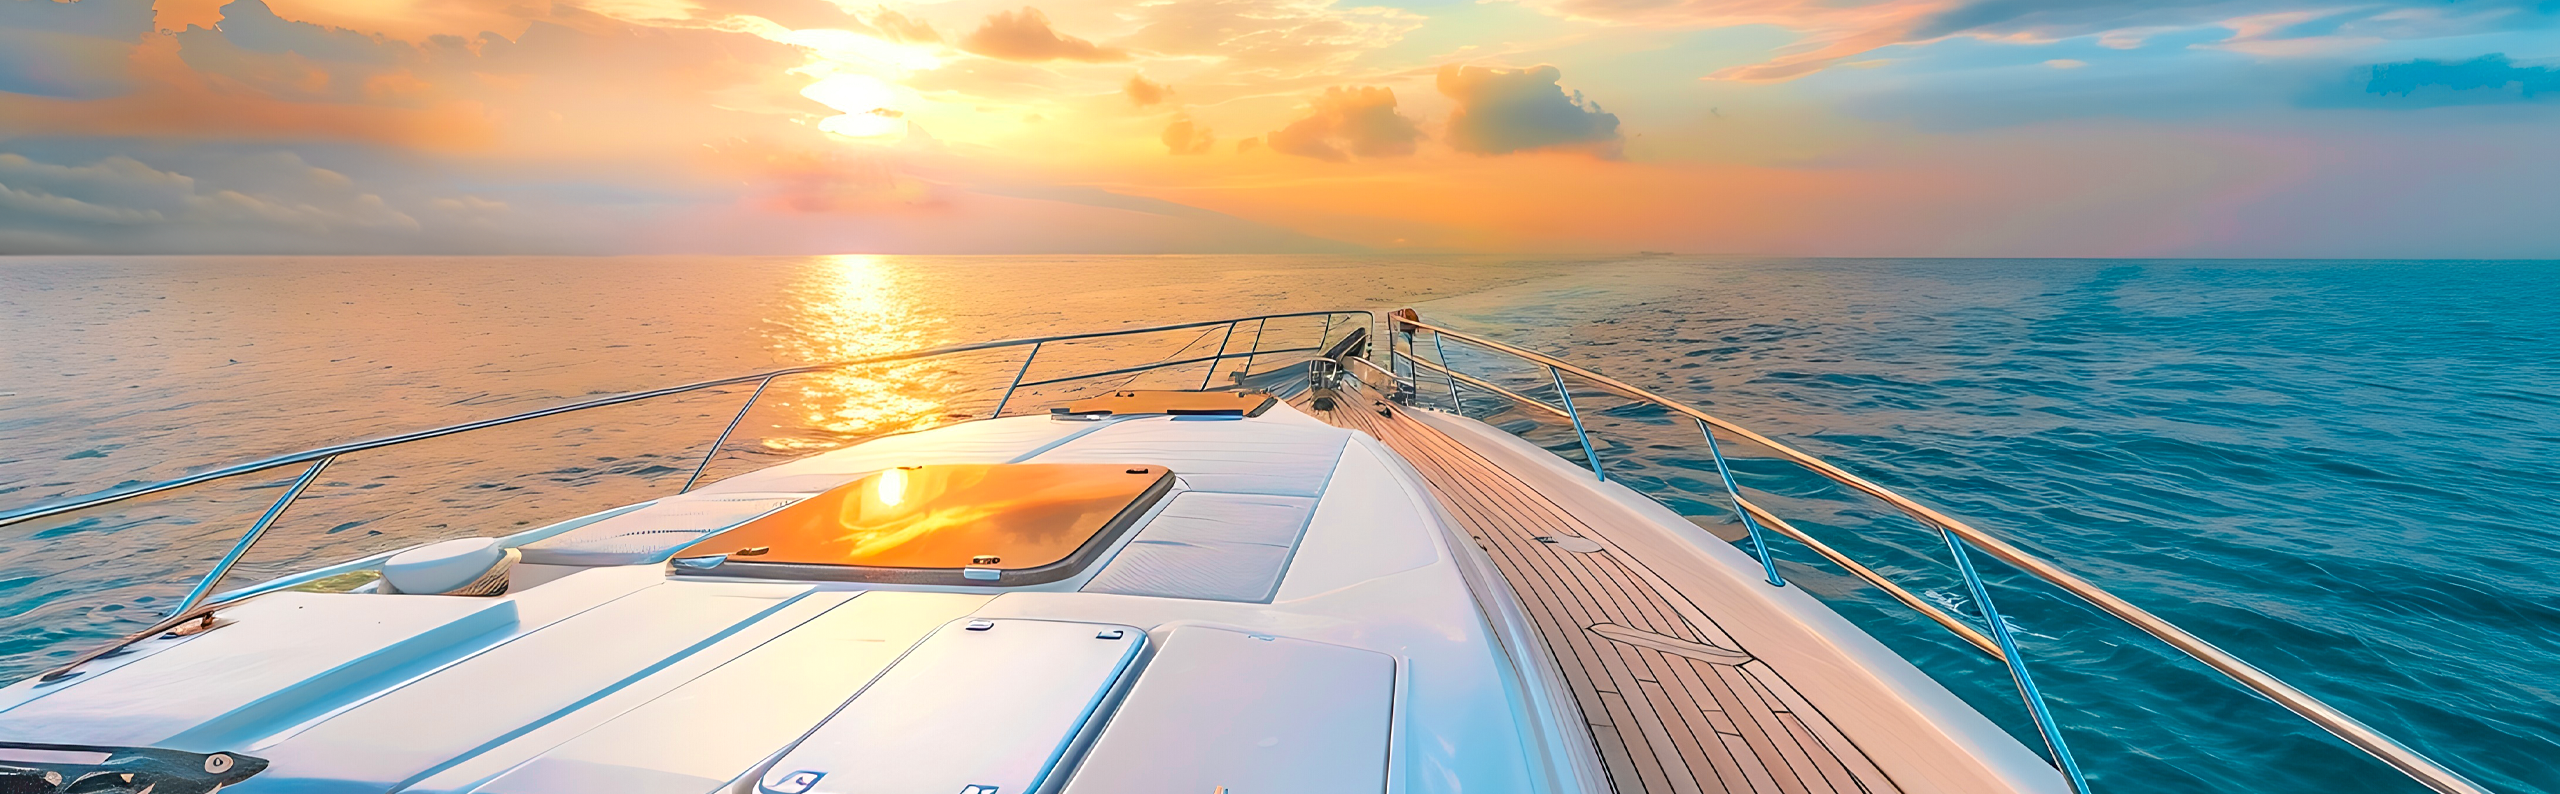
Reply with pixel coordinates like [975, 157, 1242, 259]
[1388, 310, 2488, 794]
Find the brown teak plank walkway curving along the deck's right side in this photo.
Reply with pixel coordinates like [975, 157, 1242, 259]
[1298, 392, 1902, 794]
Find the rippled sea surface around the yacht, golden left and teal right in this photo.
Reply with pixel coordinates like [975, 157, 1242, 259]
[0, 256, 2560, 794]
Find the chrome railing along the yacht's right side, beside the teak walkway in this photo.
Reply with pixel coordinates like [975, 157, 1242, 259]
[1380, 310, 2488, 794]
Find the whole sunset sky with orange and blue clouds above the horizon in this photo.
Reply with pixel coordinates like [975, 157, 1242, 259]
[0, 0, 2560, 256]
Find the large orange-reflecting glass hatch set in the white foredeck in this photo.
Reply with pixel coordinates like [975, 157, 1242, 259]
[676, 464, 1172, 571]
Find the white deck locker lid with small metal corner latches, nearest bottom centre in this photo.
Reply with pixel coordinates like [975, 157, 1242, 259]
[758, 620, 1147, 794]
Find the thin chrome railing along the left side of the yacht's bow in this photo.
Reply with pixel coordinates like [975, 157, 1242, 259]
[0, 310, 1377, 679]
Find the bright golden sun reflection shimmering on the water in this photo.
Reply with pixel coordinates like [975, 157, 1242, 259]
[765, 256, 952, 453]
